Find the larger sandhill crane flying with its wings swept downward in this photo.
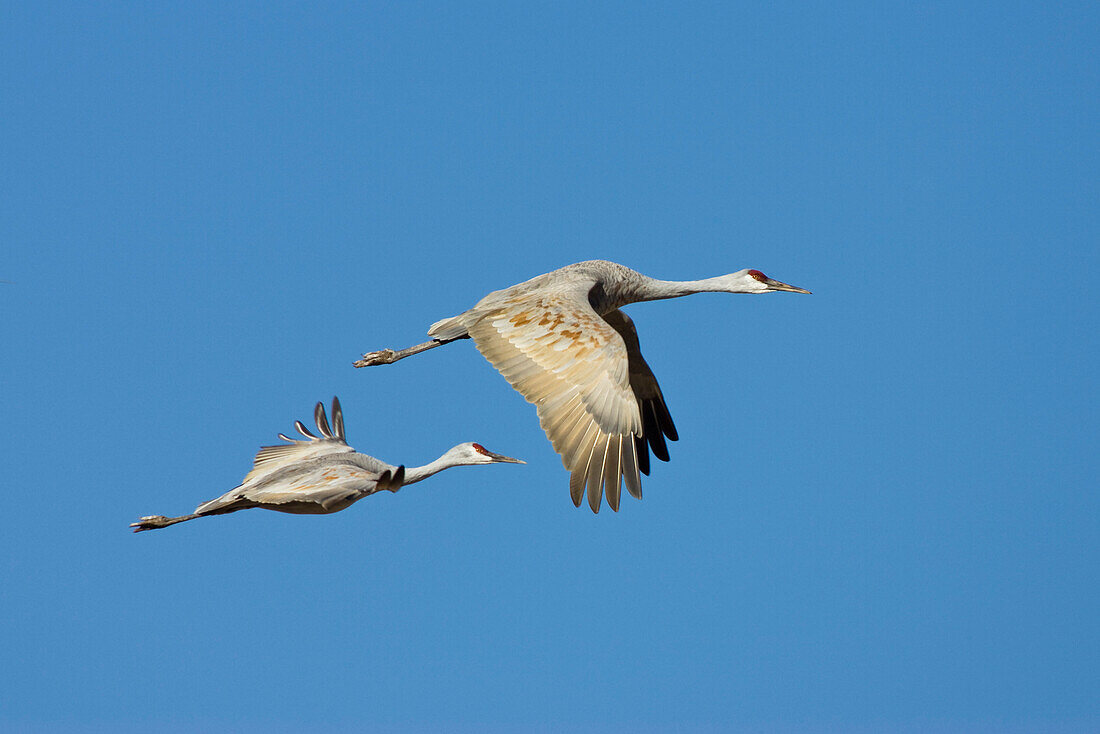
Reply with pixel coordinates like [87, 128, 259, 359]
[355, 260, 810, 513]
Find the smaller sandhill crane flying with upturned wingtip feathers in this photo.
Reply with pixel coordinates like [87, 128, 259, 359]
[130, 397, 526, 533]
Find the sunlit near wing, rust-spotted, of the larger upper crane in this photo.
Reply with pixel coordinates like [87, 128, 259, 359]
[470, 281, 642, 512]
